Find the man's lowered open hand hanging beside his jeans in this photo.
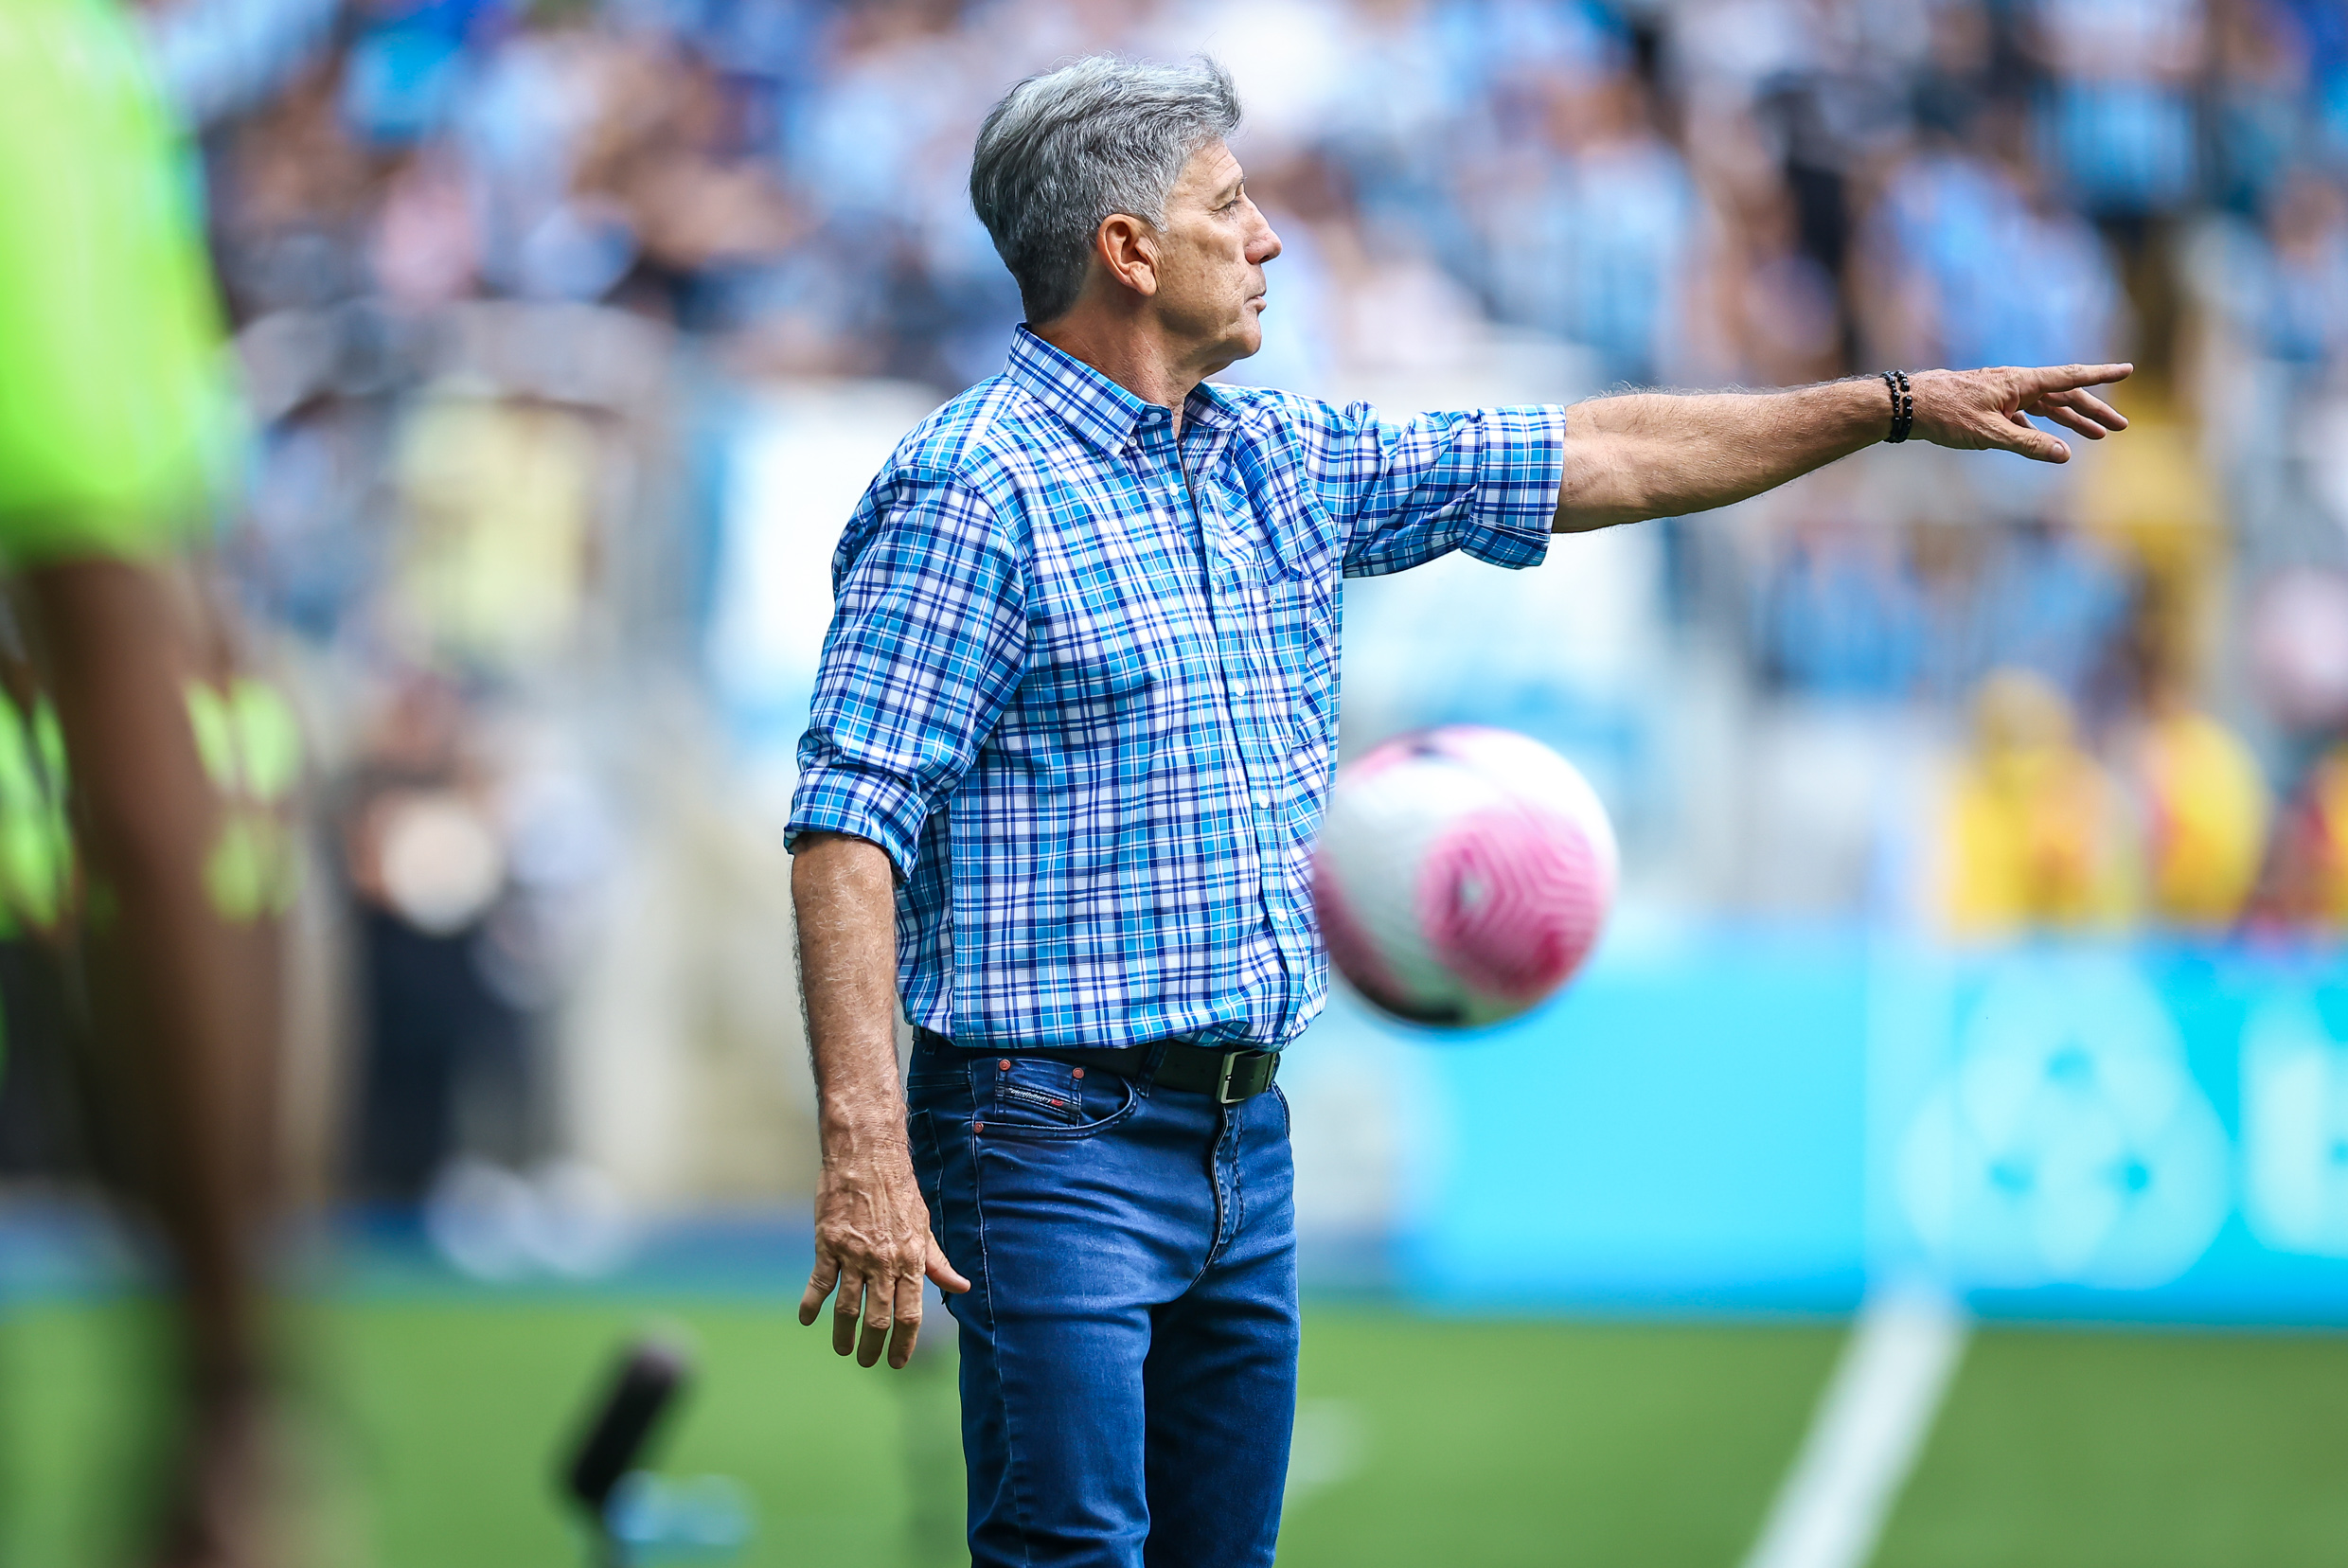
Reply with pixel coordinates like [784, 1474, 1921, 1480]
[798, 1133, 969, 1366]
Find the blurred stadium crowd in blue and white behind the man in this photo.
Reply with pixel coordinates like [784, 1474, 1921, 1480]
[0, 0, 2348, 1202]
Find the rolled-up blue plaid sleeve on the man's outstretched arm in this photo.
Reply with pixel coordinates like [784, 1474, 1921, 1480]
[1306, 403, 1566, 578]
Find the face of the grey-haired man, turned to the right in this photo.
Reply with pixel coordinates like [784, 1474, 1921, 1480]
[1155, 141, 1280, 376]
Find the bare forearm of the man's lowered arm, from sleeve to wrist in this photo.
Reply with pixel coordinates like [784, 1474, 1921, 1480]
[792, 833, 904, 1162]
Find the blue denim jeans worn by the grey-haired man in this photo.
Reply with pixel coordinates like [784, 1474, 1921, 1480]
[906, 1049, 1296, 1568]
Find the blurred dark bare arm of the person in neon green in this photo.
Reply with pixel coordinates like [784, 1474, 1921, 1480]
[21, 561, 277, 1395]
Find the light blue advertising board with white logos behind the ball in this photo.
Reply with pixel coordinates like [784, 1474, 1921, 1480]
[1293, 930, 2348, 1322]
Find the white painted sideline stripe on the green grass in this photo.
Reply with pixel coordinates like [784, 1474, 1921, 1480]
[1745, 1291, 1967, 1568]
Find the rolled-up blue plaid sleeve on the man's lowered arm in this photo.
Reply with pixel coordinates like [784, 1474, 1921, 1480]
[784, 472, 1028, 878]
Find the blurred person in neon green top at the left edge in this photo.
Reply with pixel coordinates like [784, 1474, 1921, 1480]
[0, 0, 298, 1568]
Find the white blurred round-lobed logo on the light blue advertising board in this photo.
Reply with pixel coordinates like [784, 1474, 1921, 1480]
[1899, 960, 2231, 1289]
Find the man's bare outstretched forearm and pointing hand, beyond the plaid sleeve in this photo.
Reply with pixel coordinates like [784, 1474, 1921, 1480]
[1556, 364, 2134, 533]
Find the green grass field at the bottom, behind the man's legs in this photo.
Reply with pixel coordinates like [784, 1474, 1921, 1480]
[13, 1298, 2348, 1568]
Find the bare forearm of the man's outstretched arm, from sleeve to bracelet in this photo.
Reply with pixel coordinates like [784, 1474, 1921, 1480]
[1556, 378, 1890, 533]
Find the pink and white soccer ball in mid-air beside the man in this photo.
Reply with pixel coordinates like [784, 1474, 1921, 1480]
[1312, 725, 1620, 1025]
